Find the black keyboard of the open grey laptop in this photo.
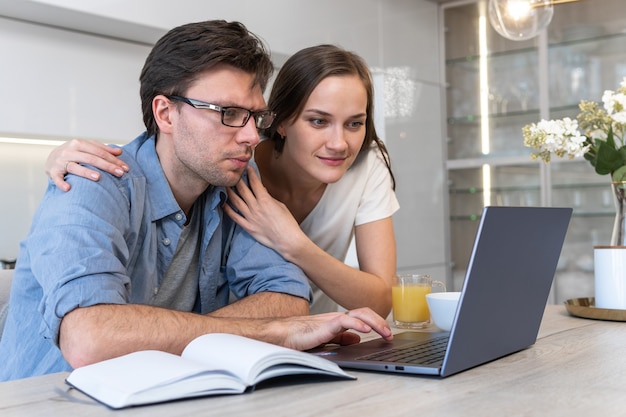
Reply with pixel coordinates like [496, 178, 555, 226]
[358, 336, 448, 365]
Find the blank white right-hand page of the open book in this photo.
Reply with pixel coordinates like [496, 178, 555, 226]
[182, 333, 354, 386]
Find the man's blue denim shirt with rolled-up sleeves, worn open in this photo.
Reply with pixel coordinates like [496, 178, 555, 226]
[0, 133, 311, 381]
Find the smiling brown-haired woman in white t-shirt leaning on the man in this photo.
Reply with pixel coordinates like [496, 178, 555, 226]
[46, 45, 399, 317]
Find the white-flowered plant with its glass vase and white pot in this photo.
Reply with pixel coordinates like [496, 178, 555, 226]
[522, 77, 626, 310]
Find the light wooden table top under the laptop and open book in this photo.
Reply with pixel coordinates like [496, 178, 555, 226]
[0, 305, 626, 417]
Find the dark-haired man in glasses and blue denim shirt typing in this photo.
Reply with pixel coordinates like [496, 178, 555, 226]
[0, 21, 391, 380]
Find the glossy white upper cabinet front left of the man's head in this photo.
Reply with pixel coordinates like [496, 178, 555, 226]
[0, 17, 150, 142]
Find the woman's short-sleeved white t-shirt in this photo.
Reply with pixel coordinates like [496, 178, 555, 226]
[300, 144, 400, 314]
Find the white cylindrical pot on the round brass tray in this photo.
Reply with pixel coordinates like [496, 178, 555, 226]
[593, 246, 626, 310]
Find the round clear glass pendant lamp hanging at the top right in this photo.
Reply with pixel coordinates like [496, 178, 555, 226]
[489, 0, 554, 41]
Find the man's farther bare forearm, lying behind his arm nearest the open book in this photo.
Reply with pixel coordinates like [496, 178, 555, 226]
[210, 292, 309, 318]
